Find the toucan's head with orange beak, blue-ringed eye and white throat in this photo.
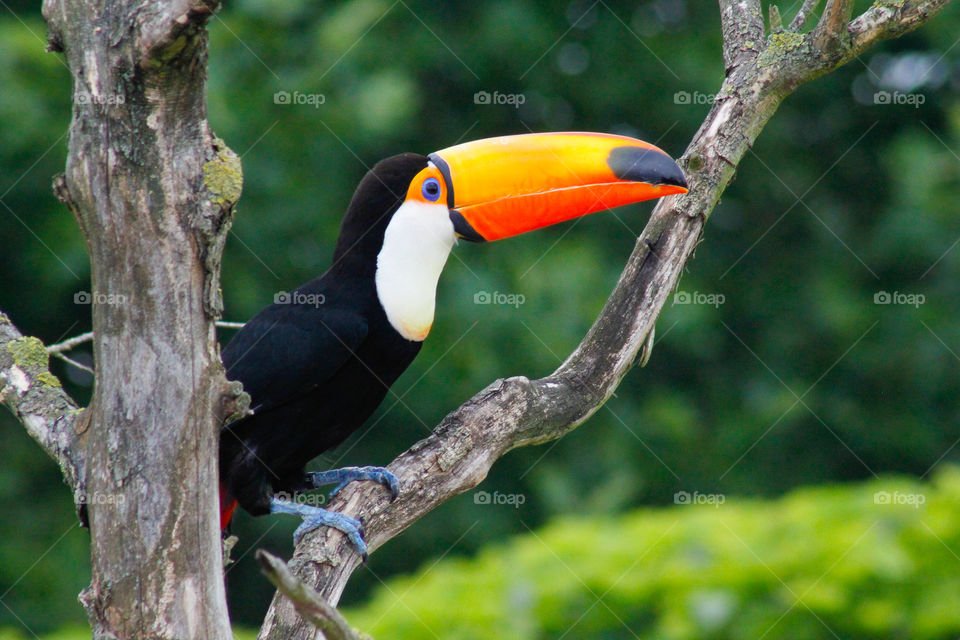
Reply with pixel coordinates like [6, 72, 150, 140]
[335, 133, 687, 340]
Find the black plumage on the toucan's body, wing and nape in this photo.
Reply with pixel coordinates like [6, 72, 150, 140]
[220, 153, 427, 524]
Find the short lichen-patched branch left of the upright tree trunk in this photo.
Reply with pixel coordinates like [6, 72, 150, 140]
[0, 311, 89, 505]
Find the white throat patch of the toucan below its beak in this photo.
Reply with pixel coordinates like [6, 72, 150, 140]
[376, 200, 456, 342]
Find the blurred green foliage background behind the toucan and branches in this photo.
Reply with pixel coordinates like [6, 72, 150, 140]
[0, 0, 960, 638]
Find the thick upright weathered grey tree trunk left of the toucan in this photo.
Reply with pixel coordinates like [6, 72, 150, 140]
[43, 0, 241, 639]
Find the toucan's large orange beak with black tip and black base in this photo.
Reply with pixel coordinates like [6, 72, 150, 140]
[430, 133, 687, 242]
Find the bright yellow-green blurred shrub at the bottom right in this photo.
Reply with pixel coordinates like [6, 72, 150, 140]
[347, 468, 960, 640]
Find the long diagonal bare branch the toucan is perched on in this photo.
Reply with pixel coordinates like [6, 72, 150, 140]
[260, 0, 948, 640]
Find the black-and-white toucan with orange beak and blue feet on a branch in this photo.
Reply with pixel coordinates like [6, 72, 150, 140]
[219, 133, 687, 557]
